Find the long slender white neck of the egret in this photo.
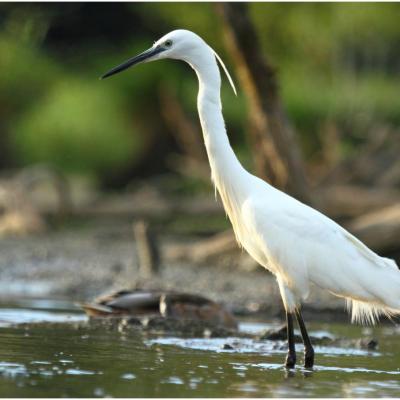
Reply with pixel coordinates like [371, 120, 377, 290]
[190, 49, 248, 232]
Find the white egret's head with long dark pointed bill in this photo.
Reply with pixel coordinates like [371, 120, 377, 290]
[101, 29, 208, 79]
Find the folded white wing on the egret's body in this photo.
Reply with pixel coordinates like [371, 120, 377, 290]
[245, 184, 399, 304]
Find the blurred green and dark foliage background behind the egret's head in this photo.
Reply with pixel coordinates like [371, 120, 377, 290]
[0, 3, 400, 188]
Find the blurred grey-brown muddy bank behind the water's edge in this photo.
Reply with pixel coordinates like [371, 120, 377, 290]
[0, 221, 348, 320]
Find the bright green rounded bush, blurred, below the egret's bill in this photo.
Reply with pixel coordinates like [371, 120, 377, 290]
[12, 79, 142, 173]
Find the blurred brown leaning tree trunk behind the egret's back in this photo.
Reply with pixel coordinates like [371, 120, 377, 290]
[216, 3, 311, 203]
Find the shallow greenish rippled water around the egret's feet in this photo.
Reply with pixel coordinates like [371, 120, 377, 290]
[0, 300, 400, 397]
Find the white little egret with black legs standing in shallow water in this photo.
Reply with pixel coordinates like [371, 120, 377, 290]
[102, 29, 400, 368]
